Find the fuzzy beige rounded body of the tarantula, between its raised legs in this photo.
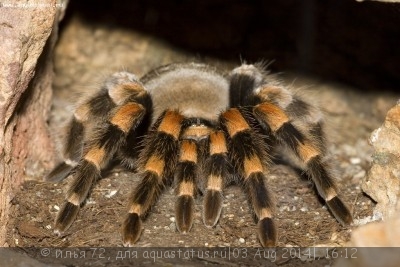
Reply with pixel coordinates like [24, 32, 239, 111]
[142, 63, 229, 121]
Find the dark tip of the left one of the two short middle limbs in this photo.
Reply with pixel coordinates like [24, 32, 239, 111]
[175, 195, 194, 233]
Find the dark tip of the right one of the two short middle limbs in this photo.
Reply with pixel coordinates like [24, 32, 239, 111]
[203, 190, 222, 227]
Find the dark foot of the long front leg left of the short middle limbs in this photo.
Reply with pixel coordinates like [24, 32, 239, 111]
[122, 213, 142, 247]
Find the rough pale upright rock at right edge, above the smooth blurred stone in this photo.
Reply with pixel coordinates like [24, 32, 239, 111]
[362, 103, 400, 220]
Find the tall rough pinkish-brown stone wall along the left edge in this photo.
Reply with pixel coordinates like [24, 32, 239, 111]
[0, 0, 65, 246]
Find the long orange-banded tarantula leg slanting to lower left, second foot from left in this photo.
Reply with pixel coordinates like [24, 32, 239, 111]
[55, 102, 145, 232]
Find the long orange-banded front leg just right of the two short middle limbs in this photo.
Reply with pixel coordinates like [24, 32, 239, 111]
[221, 108, 277, 247]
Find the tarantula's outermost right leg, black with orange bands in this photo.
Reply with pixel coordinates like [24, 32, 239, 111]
[253, 85, 352, 225]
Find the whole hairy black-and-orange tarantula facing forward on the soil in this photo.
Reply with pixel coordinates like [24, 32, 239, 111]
[47, 63, 352, 246]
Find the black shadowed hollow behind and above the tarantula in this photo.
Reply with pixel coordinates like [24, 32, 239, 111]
[64, 0, 400, 91]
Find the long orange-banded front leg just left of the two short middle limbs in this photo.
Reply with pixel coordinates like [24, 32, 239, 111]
[122, 110, 187, 246]
